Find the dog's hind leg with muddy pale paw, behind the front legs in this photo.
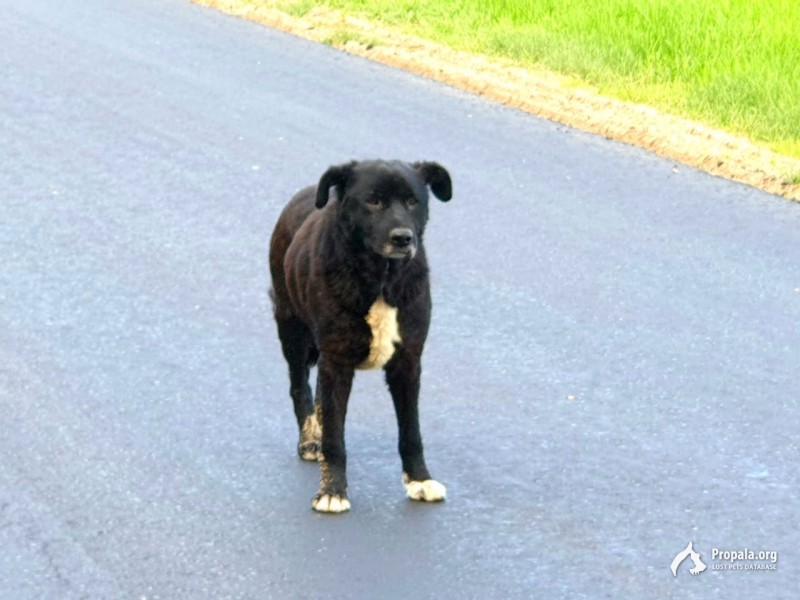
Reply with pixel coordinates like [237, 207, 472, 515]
[276, 317, 321, 461]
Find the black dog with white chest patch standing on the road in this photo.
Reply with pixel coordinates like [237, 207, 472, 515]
[269, 161, 452, 512]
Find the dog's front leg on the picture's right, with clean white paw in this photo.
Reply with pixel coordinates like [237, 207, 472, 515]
[386, 351, 447, 502]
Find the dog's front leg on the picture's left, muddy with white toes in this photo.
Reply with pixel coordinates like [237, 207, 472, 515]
[311, 356, 353, 513]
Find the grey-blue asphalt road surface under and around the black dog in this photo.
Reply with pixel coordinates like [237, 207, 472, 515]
[0, 0, 800, 600]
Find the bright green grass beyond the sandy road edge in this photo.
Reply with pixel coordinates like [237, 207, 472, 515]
[276, 0, 800, 157]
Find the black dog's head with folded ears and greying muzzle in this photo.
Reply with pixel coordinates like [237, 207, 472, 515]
[316, 161, 453, 259]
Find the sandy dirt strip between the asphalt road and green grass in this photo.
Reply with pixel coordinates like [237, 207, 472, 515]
[193, 0, 800, 200]
